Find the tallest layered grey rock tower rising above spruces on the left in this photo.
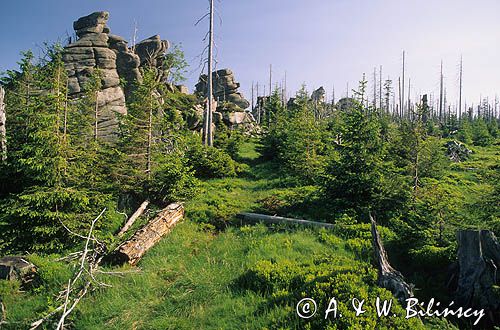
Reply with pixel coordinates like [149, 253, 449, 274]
[63, 12, 172, 141]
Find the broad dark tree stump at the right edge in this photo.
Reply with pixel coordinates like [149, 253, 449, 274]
[456, 230, 500, 312]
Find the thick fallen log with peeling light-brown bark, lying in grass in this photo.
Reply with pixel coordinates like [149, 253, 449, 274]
[111, 204, 184, 265]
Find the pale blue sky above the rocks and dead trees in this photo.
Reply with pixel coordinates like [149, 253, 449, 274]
[0, 0, 500, 108]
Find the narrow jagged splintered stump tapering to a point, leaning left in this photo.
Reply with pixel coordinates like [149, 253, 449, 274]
[370, 215, 413, 303]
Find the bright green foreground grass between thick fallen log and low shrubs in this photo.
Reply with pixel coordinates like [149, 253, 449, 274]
[75, 220, 338, 329]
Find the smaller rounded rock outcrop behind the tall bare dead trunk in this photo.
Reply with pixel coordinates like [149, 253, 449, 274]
[196, 69, 250, 111]
